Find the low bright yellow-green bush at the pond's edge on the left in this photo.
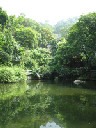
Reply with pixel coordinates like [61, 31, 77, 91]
[0, 66, 26, 83]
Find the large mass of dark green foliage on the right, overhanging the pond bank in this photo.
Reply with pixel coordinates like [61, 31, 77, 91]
[51, 13, 96, 79]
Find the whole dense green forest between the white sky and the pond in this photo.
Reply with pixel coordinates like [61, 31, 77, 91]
[0, 8, 96, 82]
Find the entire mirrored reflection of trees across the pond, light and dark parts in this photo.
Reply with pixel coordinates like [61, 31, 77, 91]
[0, 83, 96, 128]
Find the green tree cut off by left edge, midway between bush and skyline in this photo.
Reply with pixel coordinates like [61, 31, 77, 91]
[0, 24, 15, 64]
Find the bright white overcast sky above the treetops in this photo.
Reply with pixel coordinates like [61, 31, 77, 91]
[0, 0, 96, 24]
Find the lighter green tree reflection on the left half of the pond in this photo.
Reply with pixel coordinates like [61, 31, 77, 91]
[0, 82, 51, 128]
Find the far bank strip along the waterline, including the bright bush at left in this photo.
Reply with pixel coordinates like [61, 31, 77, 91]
[0, 66, 96, 83]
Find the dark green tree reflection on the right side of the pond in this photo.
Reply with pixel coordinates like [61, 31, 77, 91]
[51, 95, 96, 128]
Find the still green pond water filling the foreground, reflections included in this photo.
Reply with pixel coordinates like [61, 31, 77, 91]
[0, 81, 96, 128]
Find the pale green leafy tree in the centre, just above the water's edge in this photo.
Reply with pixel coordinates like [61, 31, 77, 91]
[24, 48, 52, 77]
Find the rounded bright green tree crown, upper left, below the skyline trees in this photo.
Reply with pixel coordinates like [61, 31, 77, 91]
[14, 27, 39, 49]
